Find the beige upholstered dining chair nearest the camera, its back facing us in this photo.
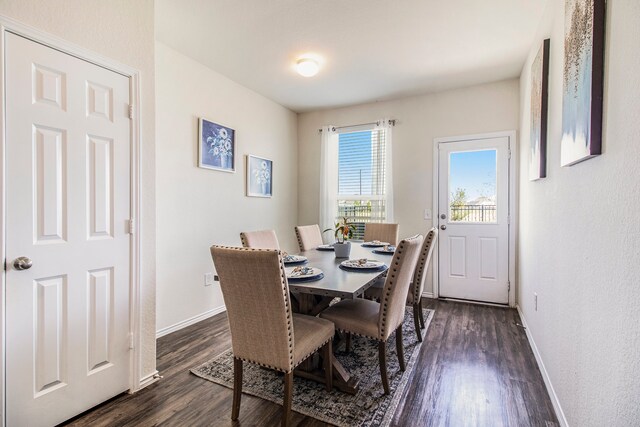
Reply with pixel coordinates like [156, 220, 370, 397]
[211, 246, 335, 426]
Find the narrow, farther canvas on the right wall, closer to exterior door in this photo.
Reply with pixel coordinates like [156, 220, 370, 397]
[529, 39, 550, 181]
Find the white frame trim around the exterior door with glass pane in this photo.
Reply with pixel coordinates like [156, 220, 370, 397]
[432, 130, 518, 307]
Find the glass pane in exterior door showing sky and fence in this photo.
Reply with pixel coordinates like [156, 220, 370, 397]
[449, 150, 497, 223]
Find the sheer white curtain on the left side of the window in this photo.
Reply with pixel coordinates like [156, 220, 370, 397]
[318, 126, 338, 242]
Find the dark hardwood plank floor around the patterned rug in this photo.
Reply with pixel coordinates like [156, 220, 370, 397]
[62, 299, 558, 427]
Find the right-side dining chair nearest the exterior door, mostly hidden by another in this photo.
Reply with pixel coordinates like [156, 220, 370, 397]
[365, 227, 438, 342]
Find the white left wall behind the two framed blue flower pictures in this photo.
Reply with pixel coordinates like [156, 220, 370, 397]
[156, 43, 298, 333]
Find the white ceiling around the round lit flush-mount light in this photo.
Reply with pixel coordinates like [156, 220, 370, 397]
[155, 0, 547, 112]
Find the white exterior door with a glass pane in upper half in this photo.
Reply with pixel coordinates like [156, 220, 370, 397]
[437, 136, 509, 304]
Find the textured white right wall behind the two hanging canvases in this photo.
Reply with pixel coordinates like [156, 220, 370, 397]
[518, 0, 640, 427]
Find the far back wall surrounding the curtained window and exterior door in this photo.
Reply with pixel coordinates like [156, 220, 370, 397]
[298, 80, 519, 292]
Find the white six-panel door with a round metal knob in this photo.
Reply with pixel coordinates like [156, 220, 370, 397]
[5, 33, 131, 427]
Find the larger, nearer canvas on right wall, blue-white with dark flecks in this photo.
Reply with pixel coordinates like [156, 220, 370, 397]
[561, 0, 606, 166]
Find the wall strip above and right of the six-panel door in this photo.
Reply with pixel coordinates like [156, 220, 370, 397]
[0, 0, 156, 384]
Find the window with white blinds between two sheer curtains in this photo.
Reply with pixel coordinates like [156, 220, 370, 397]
[337, 129, 386, 239]
